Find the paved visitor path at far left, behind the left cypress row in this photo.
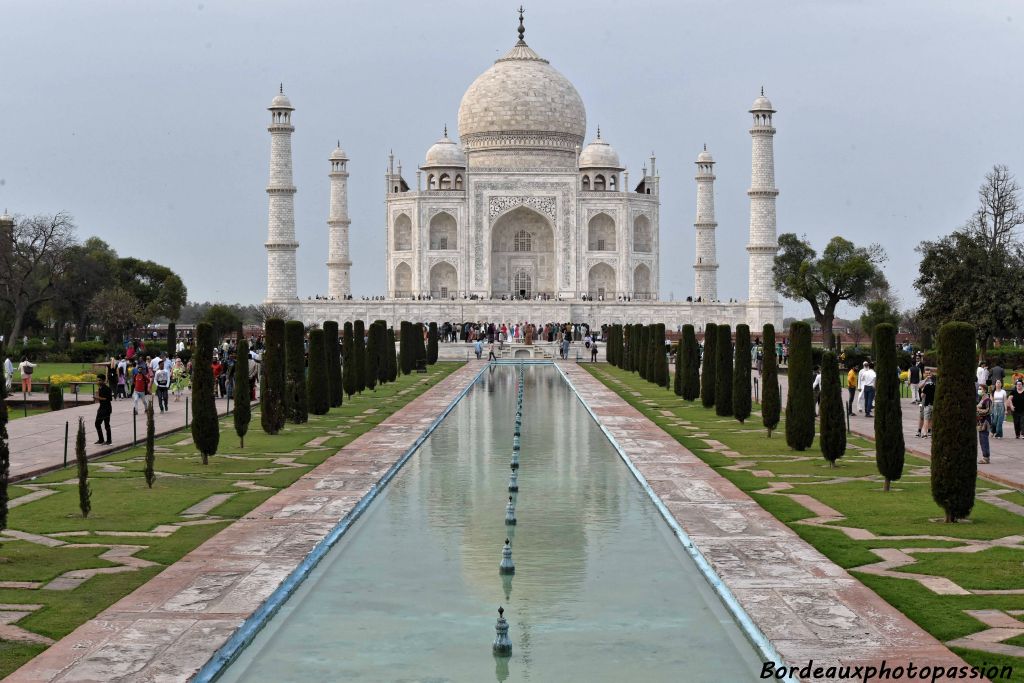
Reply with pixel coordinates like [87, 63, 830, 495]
[7, 394, 241, 480]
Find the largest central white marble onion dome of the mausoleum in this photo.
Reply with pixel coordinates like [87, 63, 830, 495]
[459, 30, 587, 164]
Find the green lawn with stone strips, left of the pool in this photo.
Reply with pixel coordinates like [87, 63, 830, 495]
[0, 362, 462, 678]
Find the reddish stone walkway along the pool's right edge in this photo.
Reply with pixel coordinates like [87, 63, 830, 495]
[562, 364, 966, 680]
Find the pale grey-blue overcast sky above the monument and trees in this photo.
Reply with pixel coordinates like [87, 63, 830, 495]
[0, 0, 1024, 316]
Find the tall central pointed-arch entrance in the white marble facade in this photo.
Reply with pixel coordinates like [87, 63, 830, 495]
[490, 207, 555, 299]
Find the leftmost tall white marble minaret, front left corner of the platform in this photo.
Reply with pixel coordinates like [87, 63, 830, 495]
[266, 85, 299, 302]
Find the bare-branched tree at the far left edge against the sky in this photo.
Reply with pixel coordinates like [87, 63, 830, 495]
[0, 211, 75, 343]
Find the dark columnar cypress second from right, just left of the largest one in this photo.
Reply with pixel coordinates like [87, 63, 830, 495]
[872, 323, 905, 490]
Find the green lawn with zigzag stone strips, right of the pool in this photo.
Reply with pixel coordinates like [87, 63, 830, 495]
[584, 364, 1024, 681]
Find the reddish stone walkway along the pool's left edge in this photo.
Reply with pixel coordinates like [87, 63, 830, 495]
[0, 364, 479, 683]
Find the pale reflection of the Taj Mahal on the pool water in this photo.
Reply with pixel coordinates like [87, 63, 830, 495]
[407, 369, 625, 603]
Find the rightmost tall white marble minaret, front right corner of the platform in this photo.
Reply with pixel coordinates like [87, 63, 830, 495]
[746, 88, 778, 303]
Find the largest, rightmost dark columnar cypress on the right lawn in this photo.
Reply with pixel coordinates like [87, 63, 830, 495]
[933, 322, 978, 522]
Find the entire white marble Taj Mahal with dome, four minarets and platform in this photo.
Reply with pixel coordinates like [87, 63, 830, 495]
[265, 12, 782, 330]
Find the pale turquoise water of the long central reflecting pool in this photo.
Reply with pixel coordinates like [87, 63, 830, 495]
[221, 366, 761, 682]
